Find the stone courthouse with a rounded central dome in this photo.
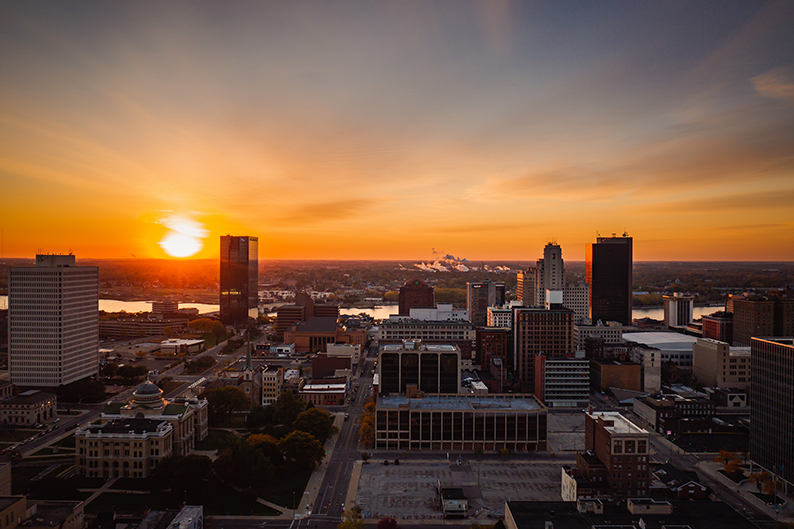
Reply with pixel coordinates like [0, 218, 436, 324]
[100, 380, 209, 456]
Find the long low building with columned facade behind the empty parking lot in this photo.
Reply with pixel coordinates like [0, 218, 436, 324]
[375, 395, 547, 452]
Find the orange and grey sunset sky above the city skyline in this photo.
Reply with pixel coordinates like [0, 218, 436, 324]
[0, 0, 794, 261]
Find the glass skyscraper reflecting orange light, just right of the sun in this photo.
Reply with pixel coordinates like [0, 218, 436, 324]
[220, 235, 259, 325]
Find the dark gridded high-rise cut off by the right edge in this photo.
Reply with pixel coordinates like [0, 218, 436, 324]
[750, 338, 794, 490]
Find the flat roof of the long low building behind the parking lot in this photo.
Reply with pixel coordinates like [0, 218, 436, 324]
[378, 395, 546, 411]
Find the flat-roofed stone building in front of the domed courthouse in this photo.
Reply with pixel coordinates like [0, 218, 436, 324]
[74, 417, 174, 478]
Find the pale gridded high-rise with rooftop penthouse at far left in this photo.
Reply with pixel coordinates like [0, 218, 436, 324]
[8, 255, 99, 387]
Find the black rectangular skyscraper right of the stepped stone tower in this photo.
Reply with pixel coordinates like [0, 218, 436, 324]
[585, 233, 633, 325]
